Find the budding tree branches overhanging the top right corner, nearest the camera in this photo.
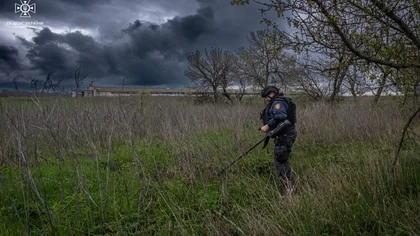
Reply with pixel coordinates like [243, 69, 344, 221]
[232, 0, 420, 166]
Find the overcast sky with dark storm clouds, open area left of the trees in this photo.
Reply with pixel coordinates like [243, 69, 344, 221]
[0, 0, 280, 89]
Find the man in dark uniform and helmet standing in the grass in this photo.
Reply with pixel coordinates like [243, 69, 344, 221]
[260, 86, 297, 195]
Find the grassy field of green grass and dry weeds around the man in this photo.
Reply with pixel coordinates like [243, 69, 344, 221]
[0, 97, 420, 235]
